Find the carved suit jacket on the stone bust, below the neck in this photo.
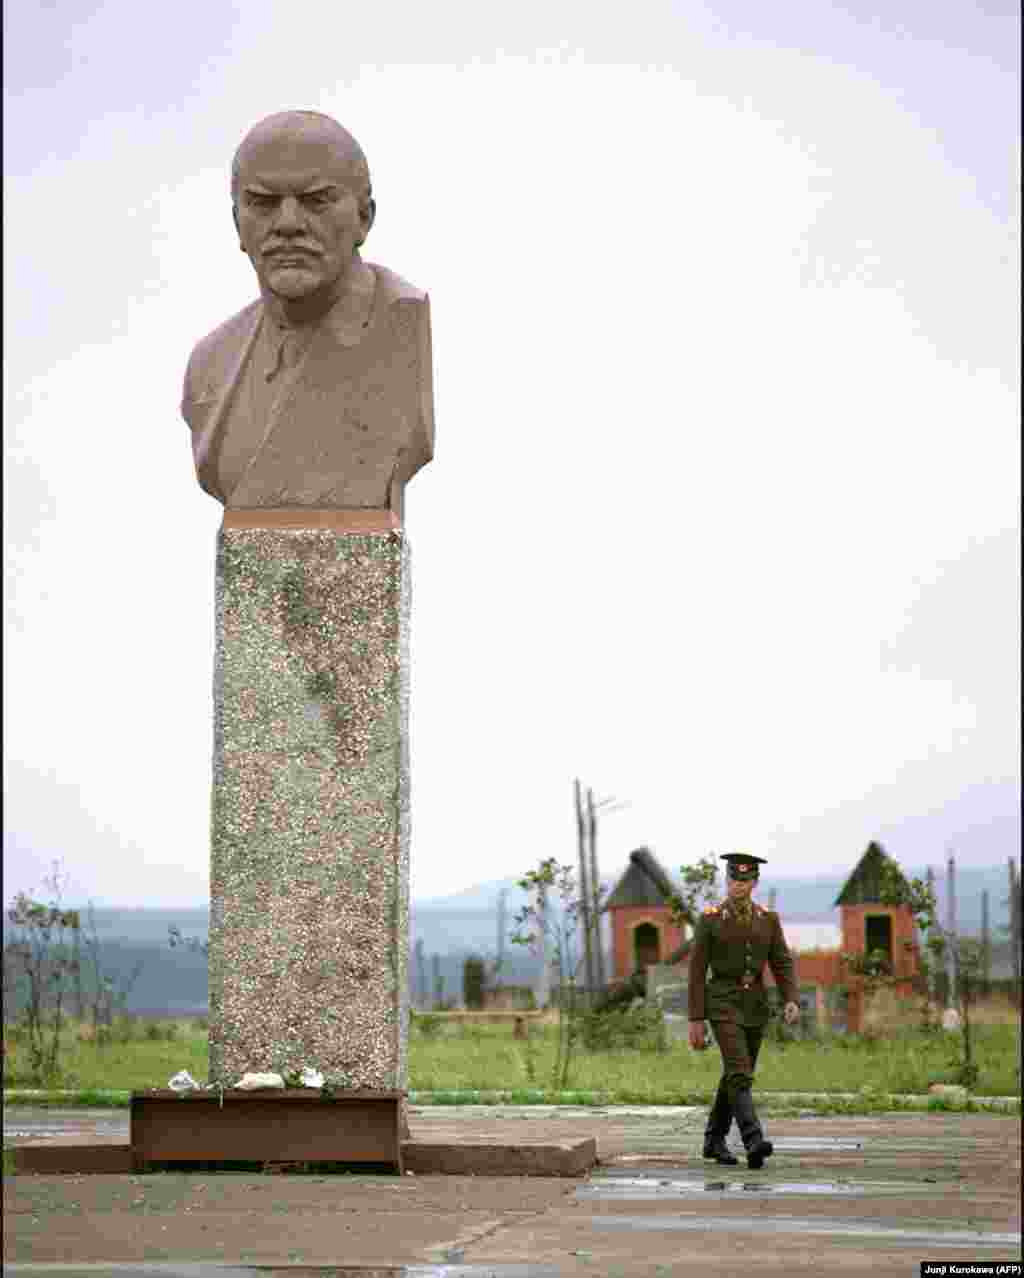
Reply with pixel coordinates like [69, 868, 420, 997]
[182, 263, 433, 516]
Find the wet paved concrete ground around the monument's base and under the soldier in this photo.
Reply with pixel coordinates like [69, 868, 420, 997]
[4, 1105, 1020, 1278]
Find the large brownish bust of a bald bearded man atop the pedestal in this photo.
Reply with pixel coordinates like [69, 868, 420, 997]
[182, 111, 433, 520]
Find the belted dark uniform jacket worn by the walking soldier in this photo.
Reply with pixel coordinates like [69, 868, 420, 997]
[689, 901, 796, 1026]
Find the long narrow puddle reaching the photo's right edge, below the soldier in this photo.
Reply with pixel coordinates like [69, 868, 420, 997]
[589, 1215, 1020, 1251]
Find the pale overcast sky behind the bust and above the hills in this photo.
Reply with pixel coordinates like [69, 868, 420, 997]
[4, 0, 1020, 905]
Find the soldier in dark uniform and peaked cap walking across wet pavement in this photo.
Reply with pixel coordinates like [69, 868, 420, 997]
[689, 852, 800, 1171]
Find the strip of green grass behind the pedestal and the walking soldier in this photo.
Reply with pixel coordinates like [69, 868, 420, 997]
[4, 1010, 1018, 1104]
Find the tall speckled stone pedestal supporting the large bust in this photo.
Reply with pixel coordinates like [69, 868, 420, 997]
[210, 511, 409, 1090]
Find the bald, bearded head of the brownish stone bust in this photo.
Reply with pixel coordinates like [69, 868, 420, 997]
[231, 111, 376, 303]
